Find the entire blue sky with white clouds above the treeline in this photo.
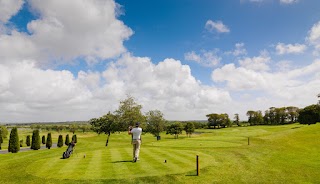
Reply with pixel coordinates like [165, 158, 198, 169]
[0, 0, 320, 123]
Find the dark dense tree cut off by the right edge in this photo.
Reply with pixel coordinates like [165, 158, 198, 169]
[298, 104, 320, 125]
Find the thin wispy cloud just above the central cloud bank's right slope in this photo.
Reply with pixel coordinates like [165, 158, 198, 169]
[184, 49, 222, 67]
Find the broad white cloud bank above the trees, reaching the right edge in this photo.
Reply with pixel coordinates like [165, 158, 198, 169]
[212, 60, 320, 105]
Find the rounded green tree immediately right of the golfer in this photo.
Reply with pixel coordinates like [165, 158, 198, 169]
[146, 110, 165, 136]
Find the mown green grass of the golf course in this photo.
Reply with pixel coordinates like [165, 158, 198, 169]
[0, 124, 320, 183]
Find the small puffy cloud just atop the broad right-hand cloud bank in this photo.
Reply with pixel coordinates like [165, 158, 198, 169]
[239, 51, 271, 71]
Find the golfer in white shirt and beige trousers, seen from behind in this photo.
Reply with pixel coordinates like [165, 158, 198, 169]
[128, 122, 142, 162]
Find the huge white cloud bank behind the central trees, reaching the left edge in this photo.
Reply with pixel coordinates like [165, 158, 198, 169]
[0, 54, 235, 122]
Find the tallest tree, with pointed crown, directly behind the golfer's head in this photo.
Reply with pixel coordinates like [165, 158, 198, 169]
[115, 95, 146, 131]
